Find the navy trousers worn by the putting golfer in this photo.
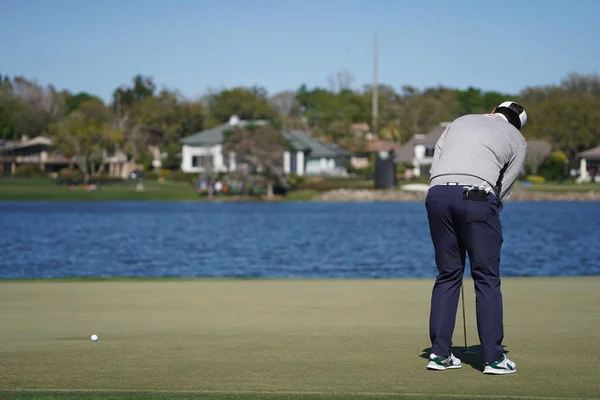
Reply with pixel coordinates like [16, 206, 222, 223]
[425, 185, 504, 362]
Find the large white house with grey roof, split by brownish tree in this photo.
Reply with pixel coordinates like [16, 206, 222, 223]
[181, 115, 351, 175]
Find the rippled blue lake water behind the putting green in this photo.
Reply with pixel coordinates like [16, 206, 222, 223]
[0, 202, 600, 278]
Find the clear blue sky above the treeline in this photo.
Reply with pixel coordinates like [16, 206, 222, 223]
[0, 0, 600, 100]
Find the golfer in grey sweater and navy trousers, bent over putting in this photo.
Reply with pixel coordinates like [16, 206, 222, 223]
[425, 101, 527, 374]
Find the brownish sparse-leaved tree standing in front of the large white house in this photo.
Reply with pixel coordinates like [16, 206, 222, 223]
[224, 124, 288, 198]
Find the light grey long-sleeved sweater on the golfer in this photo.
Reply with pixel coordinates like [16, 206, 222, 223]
[429, 114, 527, 202]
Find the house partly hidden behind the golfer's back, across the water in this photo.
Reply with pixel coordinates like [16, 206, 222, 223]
[396, 122, 450, 177]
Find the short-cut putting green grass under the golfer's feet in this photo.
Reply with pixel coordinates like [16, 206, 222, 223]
[0, 277, 600, 399]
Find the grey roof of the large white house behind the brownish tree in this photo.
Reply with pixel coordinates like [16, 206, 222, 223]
[181, 116, 350, 158]
